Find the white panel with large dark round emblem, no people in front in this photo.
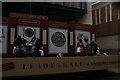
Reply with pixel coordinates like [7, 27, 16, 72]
[48, 28, 68, 54]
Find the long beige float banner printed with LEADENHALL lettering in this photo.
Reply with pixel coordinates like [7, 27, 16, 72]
[3, 56, 120, 77]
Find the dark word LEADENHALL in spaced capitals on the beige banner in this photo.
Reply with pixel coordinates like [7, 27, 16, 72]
[23, 62, 82, 70]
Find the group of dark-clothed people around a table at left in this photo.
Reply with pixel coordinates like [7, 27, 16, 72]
[13, 35, 43, 57]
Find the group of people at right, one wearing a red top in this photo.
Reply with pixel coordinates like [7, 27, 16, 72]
[76, 39, 99, 56]
